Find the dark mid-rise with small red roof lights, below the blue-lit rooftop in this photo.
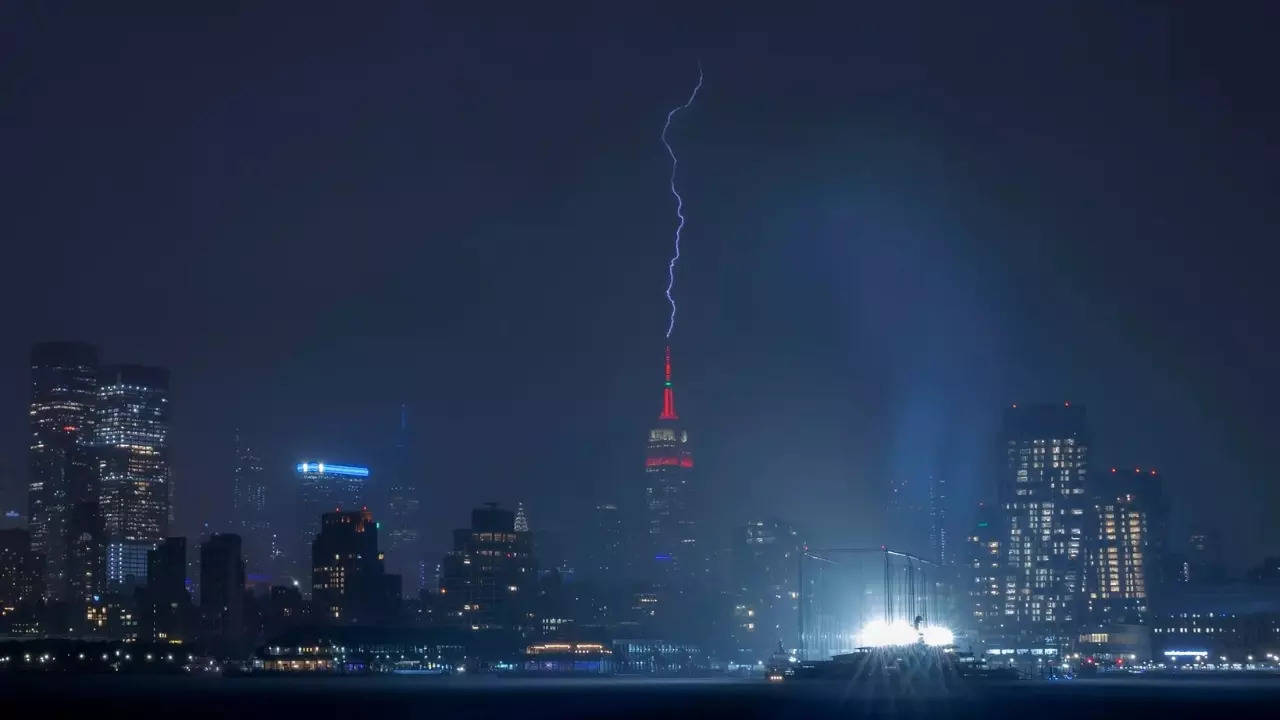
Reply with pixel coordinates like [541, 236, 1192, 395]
[311, 510, 401, 624]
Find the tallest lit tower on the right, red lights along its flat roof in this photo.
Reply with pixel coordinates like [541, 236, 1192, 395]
[1000, 404, 1089, 650]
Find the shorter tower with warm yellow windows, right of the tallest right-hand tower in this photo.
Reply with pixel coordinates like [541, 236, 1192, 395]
[1085, 468, 1165, 624]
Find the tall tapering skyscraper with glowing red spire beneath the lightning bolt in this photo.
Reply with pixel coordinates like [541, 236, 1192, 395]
[644, 346, 696, 566]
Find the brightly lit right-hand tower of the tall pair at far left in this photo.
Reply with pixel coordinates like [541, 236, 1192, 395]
[93, 365, 173, 543]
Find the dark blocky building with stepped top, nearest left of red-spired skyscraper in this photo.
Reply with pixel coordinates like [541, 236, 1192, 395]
[440, 502, 538, 629]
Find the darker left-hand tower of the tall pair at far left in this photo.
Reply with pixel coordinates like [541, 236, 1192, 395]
[28, 342, 97, 598]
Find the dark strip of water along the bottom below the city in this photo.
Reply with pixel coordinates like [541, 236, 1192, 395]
[0, 675, 1280, 720]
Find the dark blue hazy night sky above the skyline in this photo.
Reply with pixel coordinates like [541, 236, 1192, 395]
[0, 3, 1280, 569]
